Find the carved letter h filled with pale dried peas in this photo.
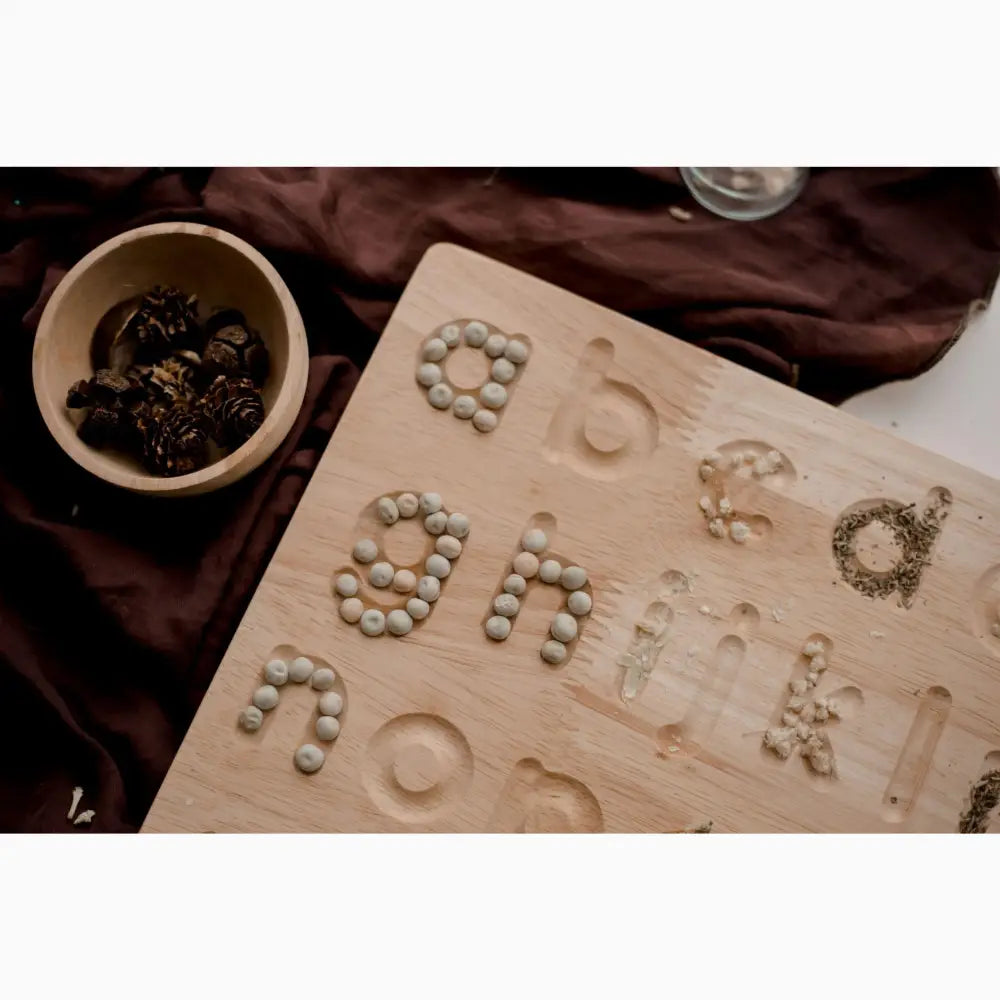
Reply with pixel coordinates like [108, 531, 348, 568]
[483, 513, 593, 667]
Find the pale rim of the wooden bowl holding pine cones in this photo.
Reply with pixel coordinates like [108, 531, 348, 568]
[31, 222, 309, 496]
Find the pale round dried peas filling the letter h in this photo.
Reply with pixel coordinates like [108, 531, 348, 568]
[483, 528, 593, 666]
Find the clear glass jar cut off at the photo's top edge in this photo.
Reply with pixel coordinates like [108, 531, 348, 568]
[681, 167, 809, 221]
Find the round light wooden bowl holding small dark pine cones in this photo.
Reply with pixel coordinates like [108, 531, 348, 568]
[32, 222, 309, 496]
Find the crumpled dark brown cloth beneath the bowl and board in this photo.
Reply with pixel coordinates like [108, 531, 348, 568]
[0, 168, 1000, 831]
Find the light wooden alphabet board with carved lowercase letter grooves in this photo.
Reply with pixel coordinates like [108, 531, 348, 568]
[145, 246, 1000, 832]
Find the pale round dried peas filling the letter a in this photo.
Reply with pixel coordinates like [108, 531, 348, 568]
[416, 319, 529, 434]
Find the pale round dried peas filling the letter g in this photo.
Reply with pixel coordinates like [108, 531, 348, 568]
[333, 492, 470, 637]
